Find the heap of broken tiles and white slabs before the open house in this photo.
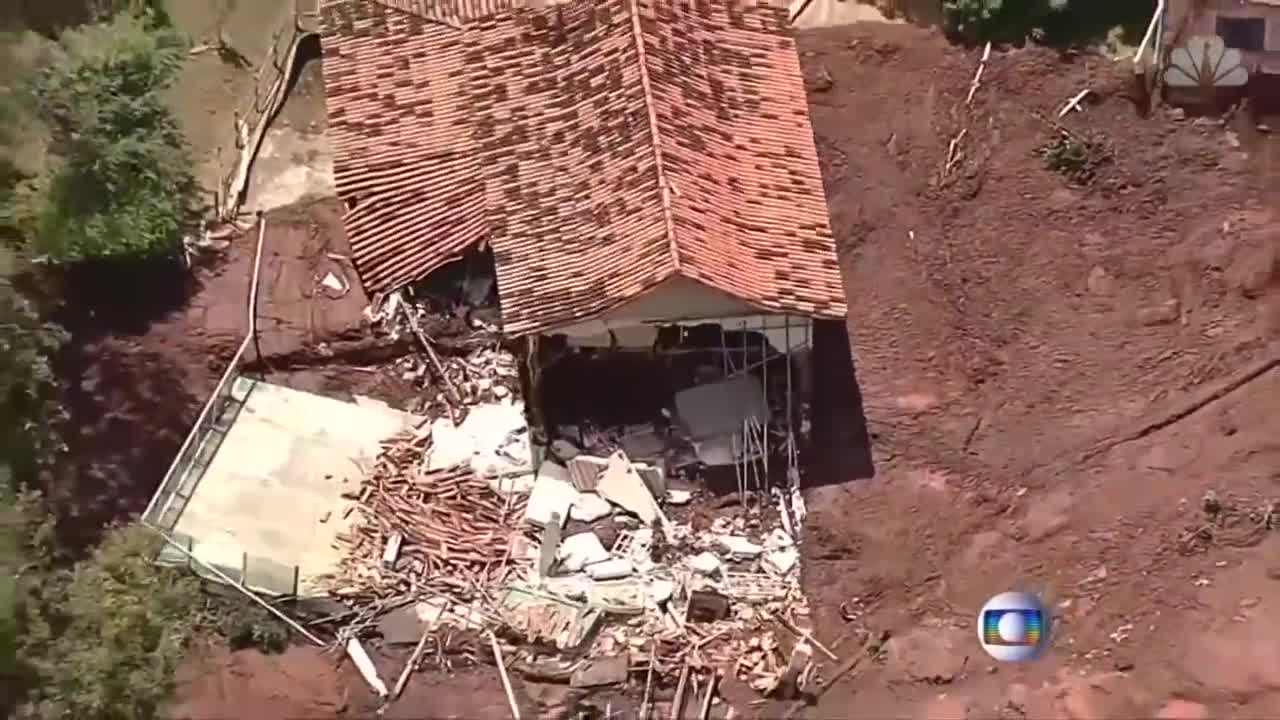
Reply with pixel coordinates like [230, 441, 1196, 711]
[333, 296, 819, 716]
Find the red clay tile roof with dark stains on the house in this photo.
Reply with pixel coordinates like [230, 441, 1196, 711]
[323, 0, 845, 334]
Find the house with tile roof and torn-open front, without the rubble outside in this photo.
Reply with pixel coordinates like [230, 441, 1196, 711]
[321, 0, 846, 491]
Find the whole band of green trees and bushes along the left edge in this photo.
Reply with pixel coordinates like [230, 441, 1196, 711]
[0, 0, 288, 720]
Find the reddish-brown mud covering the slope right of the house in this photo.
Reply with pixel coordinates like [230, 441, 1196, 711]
[800, 19, 1280, 717]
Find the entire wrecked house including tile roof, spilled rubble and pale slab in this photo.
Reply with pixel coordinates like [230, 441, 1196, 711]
[132, 0, 852, 717]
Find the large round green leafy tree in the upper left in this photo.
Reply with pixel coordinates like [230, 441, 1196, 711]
[14, 13, 195, 263]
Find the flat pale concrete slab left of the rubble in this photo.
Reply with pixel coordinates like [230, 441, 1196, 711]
[174, 378, 417, 596]
